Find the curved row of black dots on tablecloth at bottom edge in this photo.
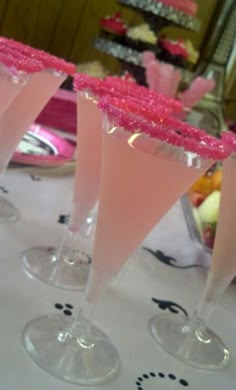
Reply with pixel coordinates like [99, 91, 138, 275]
[135, 371, 189, 390]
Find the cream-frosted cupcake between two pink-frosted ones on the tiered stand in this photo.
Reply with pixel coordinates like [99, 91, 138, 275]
[126, 23, 157, 51]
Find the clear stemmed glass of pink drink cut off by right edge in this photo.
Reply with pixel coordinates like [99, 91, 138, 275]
[150, 133, 236, 370]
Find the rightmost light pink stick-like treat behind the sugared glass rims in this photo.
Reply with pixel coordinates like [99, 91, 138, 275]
[180, 77, 215, 107]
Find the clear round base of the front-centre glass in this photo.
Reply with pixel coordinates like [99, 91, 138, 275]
[23, 315, 120, 385]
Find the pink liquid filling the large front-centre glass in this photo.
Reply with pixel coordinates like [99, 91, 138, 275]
[93, 132, 212, 274]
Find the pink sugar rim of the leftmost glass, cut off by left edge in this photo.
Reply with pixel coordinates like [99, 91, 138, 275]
[0, 51, 43, 73]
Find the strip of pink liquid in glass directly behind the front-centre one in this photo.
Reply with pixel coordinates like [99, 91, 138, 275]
[70, 94, 102, 231]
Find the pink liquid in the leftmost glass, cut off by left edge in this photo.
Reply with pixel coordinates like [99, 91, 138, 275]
[0, 65, 24, 117]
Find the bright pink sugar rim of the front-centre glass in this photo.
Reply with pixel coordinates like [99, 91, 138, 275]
[98, 97, 232, 160]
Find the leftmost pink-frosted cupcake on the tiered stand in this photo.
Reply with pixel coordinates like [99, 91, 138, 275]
[100, 12, 127, 43]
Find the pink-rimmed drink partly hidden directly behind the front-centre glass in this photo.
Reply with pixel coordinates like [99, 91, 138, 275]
[69, 74, 182, 231]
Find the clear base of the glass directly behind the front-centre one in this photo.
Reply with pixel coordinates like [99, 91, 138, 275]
[22, 247, 90, 290]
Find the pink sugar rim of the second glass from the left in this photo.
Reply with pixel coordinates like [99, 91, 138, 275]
[0, 37, 76, 75]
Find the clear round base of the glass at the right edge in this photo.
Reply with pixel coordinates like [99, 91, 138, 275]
[149, 314, 230, 370]
